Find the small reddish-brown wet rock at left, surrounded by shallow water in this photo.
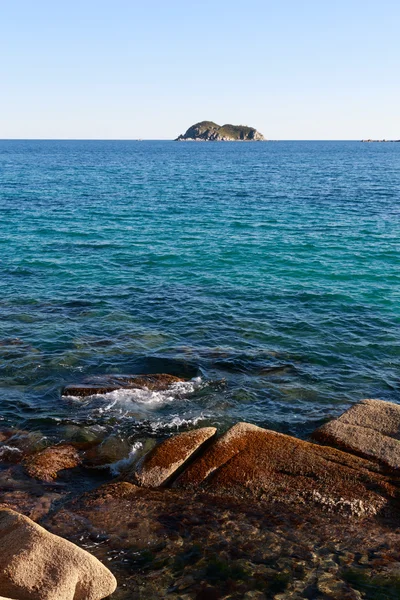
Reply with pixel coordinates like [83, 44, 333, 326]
[24, 445, 81, 481]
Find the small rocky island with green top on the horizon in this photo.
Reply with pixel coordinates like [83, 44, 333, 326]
[175, 121, 264, 142]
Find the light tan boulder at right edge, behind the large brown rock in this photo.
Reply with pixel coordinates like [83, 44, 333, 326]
[312, 400, 400, 469]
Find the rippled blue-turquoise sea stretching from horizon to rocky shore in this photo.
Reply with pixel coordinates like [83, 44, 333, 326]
[0, 141, 400, 447]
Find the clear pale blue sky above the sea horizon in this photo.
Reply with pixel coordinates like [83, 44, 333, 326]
[0, 0, 400, 140]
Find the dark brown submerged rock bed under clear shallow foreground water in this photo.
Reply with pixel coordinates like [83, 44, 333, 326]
[45, 482, 400, 600]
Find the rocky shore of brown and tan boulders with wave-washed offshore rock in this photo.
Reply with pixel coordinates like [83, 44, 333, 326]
[0, 374, 400, 600]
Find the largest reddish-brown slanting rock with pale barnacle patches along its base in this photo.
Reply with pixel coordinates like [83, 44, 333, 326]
[173, 423, 397, 516]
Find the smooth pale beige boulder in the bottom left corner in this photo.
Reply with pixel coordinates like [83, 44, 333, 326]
[0, 510, 117, 600]
